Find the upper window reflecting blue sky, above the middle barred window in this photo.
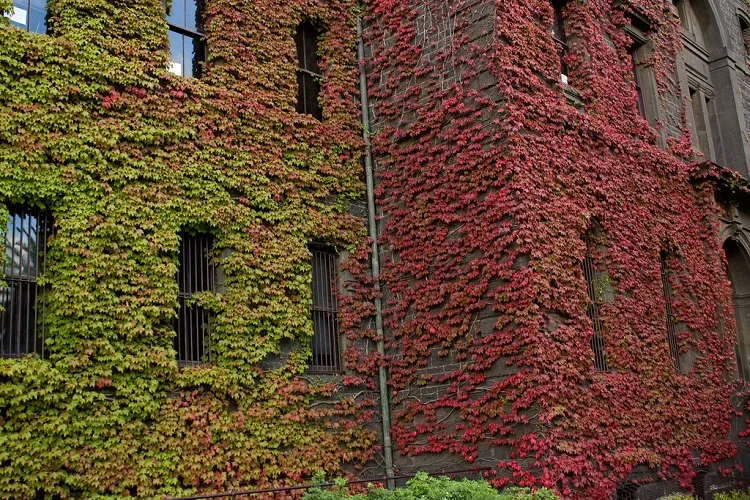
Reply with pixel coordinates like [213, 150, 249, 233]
[167, 0, 206, 78]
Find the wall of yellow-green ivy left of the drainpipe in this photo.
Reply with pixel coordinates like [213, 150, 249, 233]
[0, 0, 376, 498]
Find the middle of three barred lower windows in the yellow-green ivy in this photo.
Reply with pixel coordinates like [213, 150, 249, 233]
[172, 234, 214, 366]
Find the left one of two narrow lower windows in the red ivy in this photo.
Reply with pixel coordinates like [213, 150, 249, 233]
[581, 223, 609, 372]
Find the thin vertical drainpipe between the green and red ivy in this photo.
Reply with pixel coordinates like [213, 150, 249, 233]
[357, 9, 395, 490]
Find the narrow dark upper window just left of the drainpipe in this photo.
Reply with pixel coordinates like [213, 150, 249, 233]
[294, 22, 323, 120]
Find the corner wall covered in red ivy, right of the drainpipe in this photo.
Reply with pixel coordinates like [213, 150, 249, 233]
[360, 0, 748, 499]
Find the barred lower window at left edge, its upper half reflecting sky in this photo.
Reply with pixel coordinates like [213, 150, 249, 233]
[0, 207, 52, 357]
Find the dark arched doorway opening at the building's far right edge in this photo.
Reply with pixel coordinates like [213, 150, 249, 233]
[724, 239, 750, 380]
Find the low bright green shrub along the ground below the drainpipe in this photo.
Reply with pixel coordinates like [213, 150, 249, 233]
[304, 472, 557, 500]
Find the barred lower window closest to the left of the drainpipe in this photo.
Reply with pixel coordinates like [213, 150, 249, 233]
[310, 248, 341, 373]
